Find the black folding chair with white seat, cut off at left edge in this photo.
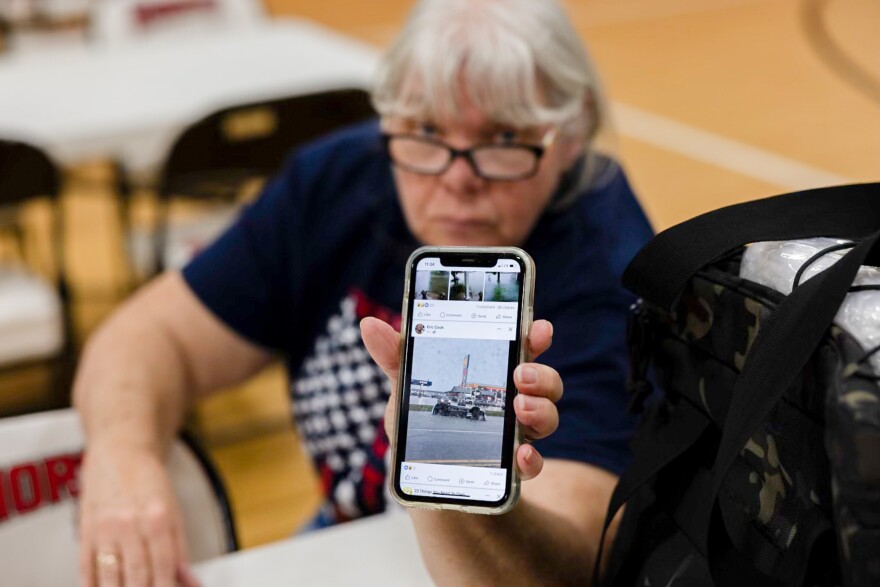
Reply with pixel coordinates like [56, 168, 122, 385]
[0, 140, 74, 414]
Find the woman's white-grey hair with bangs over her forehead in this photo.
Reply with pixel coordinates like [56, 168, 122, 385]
[373, 0, 604, 143]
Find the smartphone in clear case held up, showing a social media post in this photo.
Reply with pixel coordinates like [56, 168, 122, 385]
[389, 247, 535, 514]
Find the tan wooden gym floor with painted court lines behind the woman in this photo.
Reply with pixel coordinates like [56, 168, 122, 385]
[22, 0, 880, 547]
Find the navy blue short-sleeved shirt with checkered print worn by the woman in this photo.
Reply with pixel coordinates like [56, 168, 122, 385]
[183, 122, 652, 520]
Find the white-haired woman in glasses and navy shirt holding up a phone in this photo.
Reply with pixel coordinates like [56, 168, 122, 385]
[75, 0, 651, 585]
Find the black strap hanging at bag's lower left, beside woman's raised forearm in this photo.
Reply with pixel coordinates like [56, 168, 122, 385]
[593, 401, 710, 587]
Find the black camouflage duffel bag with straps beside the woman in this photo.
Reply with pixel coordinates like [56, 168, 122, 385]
[596, 184, 880, 587]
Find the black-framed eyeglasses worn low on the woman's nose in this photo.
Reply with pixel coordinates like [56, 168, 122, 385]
[382, 128, 558, 181]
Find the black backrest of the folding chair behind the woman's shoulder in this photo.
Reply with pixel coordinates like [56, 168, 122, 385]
[159, 89, 376, 198]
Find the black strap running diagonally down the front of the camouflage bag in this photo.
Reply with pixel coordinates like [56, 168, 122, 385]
[688, 232, 880, 586]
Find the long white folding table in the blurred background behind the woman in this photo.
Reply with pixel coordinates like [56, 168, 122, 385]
[0, 19, 378, 175]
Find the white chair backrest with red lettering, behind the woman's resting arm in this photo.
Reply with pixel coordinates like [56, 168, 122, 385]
[0, 409, 237, 585]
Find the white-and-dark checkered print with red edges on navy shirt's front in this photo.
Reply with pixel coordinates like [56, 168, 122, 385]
[290, 291, 400, 521]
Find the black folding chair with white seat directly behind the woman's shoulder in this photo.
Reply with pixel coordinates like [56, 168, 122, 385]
[123, 89, 376, 278]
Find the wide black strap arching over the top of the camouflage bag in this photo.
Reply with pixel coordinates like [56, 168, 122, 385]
[623, 183, 880, 309]
